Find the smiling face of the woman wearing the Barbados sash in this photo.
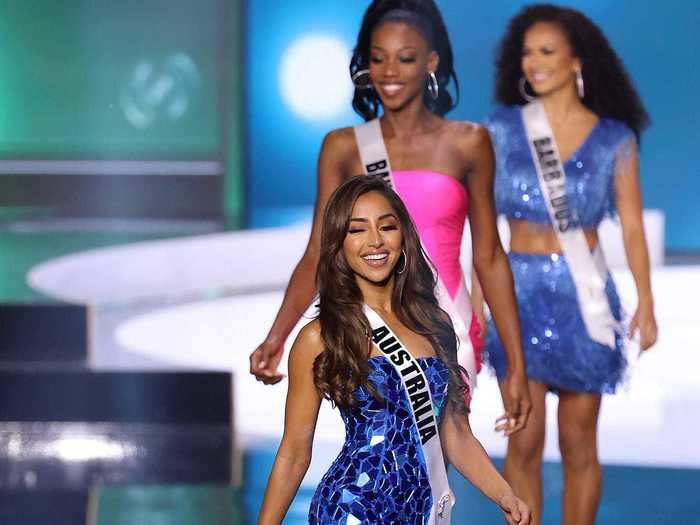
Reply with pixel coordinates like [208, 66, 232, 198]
[521, 22, 581, 96]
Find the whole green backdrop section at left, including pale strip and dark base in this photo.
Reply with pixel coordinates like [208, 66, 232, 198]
[0, 0, 246, 219]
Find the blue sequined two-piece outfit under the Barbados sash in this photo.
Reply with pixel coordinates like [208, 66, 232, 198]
[485, 106, 635, 393]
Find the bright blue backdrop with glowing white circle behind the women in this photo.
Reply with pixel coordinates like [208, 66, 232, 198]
[246, 0, 700, 251]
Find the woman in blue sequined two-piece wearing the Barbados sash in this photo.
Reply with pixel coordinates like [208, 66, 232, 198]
[486, 5, 657, 524]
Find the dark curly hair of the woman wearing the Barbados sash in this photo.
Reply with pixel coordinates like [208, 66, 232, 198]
[494, 4, 649, 142]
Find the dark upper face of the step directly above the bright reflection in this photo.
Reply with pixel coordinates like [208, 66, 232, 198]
[0, 365, 231, 425]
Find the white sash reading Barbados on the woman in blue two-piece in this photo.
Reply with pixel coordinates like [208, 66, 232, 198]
[522, 100, 619, 349]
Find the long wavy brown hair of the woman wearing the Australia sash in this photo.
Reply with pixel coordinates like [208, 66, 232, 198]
[314, 175, 468, 412]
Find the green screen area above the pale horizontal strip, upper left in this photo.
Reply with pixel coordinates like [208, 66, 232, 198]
[0, 0, 221, 159]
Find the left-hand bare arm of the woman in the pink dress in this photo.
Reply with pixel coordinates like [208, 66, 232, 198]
[250, 128, 354, 385]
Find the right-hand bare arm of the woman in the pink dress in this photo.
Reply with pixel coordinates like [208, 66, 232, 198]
[467, 127, 532, 435]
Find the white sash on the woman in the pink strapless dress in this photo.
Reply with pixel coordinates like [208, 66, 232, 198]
[354, 119, 476, 386]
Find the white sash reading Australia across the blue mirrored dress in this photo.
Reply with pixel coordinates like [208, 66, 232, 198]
[364, 305, 455, 525]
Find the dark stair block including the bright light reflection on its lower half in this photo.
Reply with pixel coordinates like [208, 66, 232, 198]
[0, 364, 234, 491]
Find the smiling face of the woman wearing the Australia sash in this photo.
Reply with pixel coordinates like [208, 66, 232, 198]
[343, 191, 403, 285]
